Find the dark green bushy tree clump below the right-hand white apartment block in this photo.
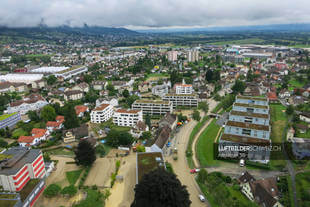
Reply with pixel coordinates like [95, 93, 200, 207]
[106, 129, 134, 147]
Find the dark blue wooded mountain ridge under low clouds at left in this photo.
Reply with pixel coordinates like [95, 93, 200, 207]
[0, 25, 144, 44]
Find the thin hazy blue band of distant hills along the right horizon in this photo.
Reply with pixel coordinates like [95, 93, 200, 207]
[136, 23, 310, 33]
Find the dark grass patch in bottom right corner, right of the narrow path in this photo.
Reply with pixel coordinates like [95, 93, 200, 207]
[296, 172, 310, 207]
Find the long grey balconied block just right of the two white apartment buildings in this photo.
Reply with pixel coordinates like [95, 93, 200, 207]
[131, 99, 173, 115]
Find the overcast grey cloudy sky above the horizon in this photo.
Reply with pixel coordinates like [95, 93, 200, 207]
[0, 0, 310, 29]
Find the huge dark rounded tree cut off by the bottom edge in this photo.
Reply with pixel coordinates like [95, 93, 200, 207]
[131, 168, 191, 207]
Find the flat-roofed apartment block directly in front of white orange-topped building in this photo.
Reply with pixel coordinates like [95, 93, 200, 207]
[163, 93, 198, 108]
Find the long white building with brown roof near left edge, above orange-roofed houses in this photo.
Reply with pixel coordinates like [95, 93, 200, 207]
[5, 94, 48, 115]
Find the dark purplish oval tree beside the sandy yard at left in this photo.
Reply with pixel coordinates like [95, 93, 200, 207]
[74, 139, 96, 166]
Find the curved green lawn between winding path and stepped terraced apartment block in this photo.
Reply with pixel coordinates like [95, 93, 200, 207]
[196, 119, 220, 166]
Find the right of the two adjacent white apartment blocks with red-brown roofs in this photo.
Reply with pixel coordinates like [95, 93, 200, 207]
[113, 109, 143, 127]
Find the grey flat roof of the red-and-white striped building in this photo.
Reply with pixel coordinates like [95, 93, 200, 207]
[0, 147, 41, 175]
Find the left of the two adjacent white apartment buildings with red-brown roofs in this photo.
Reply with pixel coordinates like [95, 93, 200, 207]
[90, 104, 113, 123]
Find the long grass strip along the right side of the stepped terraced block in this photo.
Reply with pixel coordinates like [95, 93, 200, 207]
[270, 104, 287, 170]
